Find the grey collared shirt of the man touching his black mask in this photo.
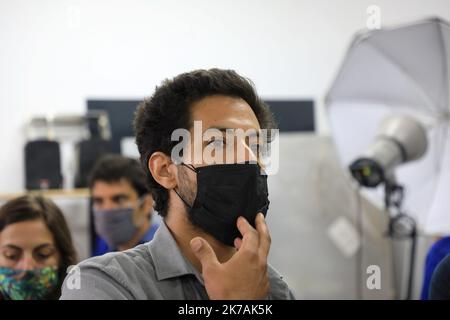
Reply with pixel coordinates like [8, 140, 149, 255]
[60, 222, 294, 300]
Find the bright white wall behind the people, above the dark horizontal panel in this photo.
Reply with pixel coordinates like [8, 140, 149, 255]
[0, 0, 450, 192]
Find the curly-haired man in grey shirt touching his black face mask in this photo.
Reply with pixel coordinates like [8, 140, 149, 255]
[61, 69, 294, 299]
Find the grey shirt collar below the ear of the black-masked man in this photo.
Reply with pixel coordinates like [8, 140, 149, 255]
[149, 221, 203, 284]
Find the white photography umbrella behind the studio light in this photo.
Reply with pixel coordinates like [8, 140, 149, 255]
[326, 19, 450, 234]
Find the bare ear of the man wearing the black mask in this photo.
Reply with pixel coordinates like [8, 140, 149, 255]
[147, 151, 177, 190]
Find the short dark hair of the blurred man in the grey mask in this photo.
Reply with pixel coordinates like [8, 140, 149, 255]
[89, 154, 148, 197]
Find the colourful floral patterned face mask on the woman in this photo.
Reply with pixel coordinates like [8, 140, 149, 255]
[0, 267, 59, 300]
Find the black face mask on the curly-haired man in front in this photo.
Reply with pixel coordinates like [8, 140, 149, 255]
[175, 163, 269, 246]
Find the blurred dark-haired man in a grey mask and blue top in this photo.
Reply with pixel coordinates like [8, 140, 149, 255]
[89, 155, 158, 256]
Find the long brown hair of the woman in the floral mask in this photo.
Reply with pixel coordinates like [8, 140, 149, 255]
[0, 195, 77, 299]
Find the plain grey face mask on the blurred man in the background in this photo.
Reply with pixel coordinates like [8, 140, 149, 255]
[93, 201, 149, 248]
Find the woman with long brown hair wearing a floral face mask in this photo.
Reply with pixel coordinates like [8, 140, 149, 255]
[0, 195, 76, 300]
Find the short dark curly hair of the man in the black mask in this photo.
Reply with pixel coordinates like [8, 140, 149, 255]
[134, 69, 276, 217]
